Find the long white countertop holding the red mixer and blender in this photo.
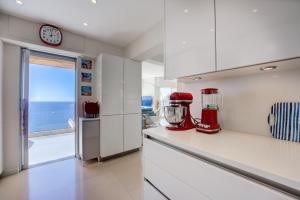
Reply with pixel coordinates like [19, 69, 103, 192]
[143, 127, 300, 191]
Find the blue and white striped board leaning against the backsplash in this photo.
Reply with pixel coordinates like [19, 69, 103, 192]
[268, 102, 300, 142]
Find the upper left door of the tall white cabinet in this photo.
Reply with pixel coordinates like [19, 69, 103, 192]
[101, 55, 124, 115]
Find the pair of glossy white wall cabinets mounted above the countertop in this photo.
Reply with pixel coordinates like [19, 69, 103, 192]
[165, 0, 300, 79]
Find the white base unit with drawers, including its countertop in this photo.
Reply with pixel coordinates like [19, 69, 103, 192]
[144, 127, 300, 200]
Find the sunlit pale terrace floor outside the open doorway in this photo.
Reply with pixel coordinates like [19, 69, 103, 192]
[28, 133, 75, 165]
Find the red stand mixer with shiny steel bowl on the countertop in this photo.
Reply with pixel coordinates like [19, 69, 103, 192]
[164, 92, 195, 131]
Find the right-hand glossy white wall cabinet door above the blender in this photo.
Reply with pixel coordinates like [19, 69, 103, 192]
[216, 0, 300, 70]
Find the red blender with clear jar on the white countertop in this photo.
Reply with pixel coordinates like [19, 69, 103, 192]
[196, 88, 221, 133]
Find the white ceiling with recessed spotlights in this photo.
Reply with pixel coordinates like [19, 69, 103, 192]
[0, 0, 163, 47]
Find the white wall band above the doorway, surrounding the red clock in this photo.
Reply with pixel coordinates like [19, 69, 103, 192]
[0, 13, 124, 57]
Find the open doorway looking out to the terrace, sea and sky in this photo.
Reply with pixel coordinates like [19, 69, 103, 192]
[22, 50, 76, 168]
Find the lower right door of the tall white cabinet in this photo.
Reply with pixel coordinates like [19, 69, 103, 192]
[124, 114, 142, 151]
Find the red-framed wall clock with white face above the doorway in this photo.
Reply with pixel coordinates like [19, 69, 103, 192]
[39, 24, 62, 46]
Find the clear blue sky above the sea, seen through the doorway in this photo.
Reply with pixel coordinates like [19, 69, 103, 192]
[29, 64, 75, 102]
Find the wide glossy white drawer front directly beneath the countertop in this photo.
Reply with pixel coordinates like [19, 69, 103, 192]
[143, 137, 295, 200]
